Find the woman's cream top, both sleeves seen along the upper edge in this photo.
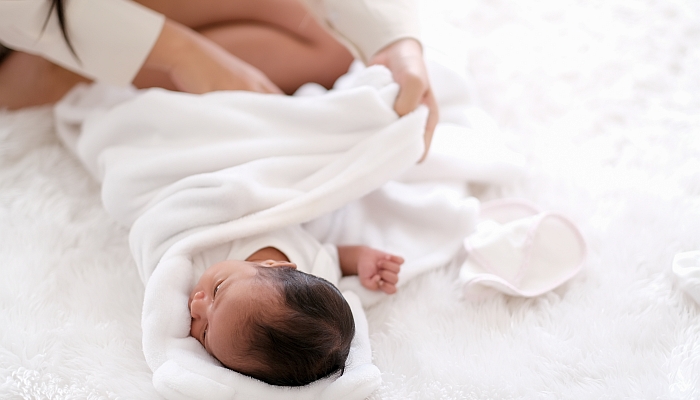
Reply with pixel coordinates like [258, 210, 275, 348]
[0, 0, 419, 86]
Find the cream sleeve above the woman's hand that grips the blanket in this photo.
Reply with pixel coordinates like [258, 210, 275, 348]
[306, 0, 420, 63]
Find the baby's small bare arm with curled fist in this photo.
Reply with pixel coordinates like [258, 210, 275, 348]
[338, 246, 403, 294]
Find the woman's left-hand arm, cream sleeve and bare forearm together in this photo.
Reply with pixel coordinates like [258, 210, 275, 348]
[0, 0, 281, 93]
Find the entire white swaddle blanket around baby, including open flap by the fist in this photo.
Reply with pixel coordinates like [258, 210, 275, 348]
[56, 60, 579, 399]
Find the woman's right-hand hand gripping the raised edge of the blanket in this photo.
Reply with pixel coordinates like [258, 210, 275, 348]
[370, 39, 439, 161]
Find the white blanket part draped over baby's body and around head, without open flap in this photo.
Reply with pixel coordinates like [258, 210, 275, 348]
[56, 67, 427, 399]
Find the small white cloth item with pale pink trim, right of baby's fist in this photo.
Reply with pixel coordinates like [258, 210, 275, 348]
[460, 200, 586, 297]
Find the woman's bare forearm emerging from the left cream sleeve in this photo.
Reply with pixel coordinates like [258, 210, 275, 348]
[139, 19, 282, 94]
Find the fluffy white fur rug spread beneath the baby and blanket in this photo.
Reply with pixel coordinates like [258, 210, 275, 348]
[0, 0, 700, 400]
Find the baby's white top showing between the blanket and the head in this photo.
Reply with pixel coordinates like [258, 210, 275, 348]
[192, 225, 340, 286]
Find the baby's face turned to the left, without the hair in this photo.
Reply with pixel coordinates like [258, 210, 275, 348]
[188, 260, 296, 370]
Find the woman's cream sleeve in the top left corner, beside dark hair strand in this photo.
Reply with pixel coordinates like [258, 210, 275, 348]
[0, 0, 165, 85]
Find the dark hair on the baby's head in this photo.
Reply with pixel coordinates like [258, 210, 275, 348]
[239, 268, 355, 386]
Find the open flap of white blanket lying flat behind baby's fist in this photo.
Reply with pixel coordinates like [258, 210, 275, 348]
[316, 181, 479, 307]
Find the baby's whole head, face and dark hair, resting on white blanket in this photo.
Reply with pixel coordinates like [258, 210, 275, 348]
[189, 260, 355, 386]
